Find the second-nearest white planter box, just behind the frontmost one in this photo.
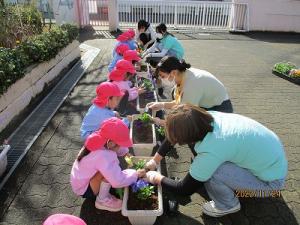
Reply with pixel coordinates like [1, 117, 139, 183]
[130, 115, 156, 156]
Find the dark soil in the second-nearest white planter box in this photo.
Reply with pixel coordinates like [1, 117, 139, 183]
[132, 120, 153, 144]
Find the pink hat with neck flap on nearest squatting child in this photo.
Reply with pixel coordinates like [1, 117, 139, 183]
[84, 117, 132, 151]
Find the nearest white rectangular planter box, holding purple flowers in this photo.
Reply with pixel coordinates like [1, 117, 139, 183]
[122, 157, 163, 225]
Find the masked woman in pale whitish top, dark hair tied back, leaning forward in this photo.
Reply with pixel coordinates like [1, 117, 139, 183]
[147, 56, 233, 162]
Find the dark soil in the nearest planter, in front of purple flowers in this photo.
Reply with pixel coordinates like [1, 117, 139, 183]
[127, 188, 158, 210]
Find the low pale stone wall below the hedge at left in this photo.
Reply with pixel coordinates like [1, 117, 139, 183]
[0, 40, 80, 132]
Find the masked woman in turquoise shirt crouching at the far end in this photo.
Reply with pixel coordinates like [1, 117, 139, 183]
[142, 23, 184, 61]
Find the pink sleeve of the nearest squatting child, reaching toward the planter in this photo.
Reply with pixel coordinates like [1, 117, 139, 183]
[98, 152, 138, 188]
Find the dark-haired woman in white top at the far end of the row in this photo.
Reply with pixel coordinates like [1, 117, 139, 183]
[135, 20, 156, 49]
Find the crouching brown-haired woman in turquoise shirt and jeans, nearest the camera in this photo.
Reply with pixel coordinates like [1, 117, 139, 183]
[146, 104, 287, 217]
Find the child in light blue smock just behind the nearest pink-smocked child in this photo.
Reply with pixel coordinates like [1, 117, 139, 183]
[80, 82, 129, 140]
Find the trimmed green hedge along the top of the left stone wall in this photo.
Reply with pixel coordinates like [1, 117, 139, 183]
[0, 24, 79, 95]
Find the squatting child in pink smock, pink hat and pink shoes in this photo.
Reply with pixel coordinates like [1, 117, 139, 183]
[71, 117, 145, 212]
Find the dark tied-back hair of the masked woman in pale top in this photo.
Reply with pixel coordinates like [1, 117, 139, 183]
[155, 56, 191, 74]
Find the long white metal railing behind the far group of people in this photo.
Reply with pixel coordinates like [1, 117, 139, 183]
[118, 0, 248, 31]
